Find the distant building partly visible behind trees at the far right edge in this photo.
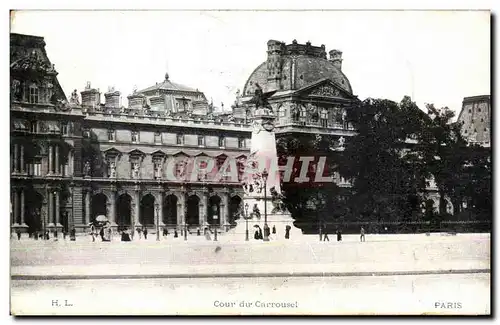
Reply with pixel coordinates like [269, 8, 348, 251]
[458, 95, 491, 147]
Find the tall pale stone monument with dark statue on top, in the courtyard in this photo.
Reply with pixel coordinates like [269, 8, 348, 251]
[229, 84, 302, 241]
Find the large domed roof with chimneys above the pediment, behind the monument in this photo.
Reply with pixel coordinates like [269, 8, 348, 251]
[243, 43, 353, 96]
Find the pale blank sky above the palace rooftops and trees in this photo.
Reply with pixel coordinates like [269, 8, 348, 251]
[11, 10, 491, 115]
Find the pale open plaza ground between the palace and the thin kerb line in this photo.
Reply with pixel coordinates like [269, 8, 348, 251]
[11, 234, 490, 277]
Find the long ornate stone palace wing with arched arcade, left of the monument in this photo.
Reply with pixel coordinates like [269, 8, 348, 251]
[10, 34, 251, 232]
